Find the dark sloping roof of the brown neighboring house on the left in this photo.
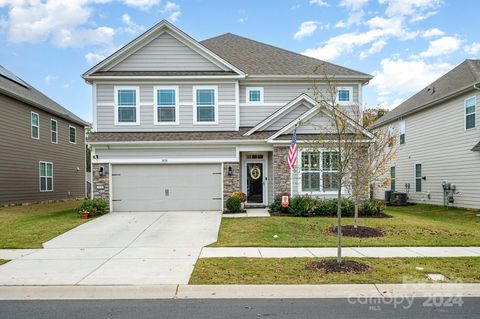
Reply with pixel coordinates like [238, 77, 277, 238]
[0, 65, 88, 126]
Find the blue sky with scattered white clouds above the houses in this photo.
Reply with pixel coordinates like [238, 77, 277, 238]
[0, 0, 480, 121]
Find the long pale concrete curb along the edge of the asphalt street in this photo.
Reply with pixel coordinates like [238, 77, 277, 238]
[0, 284, 480, 300]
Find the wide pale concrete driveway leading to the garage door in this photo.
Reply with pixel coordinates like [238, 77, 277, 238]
[0, 212, 221, 285]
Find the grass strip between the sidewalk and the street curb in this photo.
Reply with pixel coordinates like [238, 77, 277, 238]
[189, 257, 480, 285]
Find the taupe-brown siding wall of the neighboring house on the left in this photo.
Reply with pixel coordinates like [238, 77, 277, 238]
[0, 94, 85, 205]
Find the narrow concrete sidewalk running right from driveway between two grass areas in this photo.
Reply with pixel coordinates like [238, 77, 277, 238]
[200, 247, 480, 258]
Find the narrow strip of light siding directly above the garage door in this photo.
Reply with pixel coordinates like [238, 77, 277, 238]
[94, 147, 236, 163]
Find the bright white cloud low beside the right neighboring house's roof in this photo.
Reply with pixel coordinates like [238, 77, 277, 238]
[370, 58, 453, 108]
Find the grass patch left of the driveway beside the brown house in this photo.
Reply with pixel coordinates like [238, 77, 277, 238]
[0, 201, 84, 249]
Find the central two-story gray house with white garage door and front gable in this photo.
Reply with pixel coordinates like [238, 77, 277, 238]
[83, 21, 372, 211]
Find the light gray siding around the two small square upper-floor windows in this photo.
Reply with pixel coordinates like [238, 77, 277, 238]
[240, 82, 359, 127]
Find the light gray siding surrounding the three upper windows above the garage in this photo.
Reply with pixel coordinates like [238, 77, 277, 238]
[96, 81, 235, 132]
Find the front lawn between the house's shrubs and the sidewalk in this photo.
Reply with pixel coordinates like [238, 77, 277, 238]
[211, 205, 480, 247]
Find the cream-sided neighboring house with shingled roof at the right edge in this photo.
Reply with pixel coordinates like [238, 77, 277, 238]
[375, 60, 480, 208]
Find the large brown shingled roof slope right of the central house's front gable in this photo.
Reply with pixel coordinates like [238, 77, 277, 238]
[200, 33, 373, 82]
